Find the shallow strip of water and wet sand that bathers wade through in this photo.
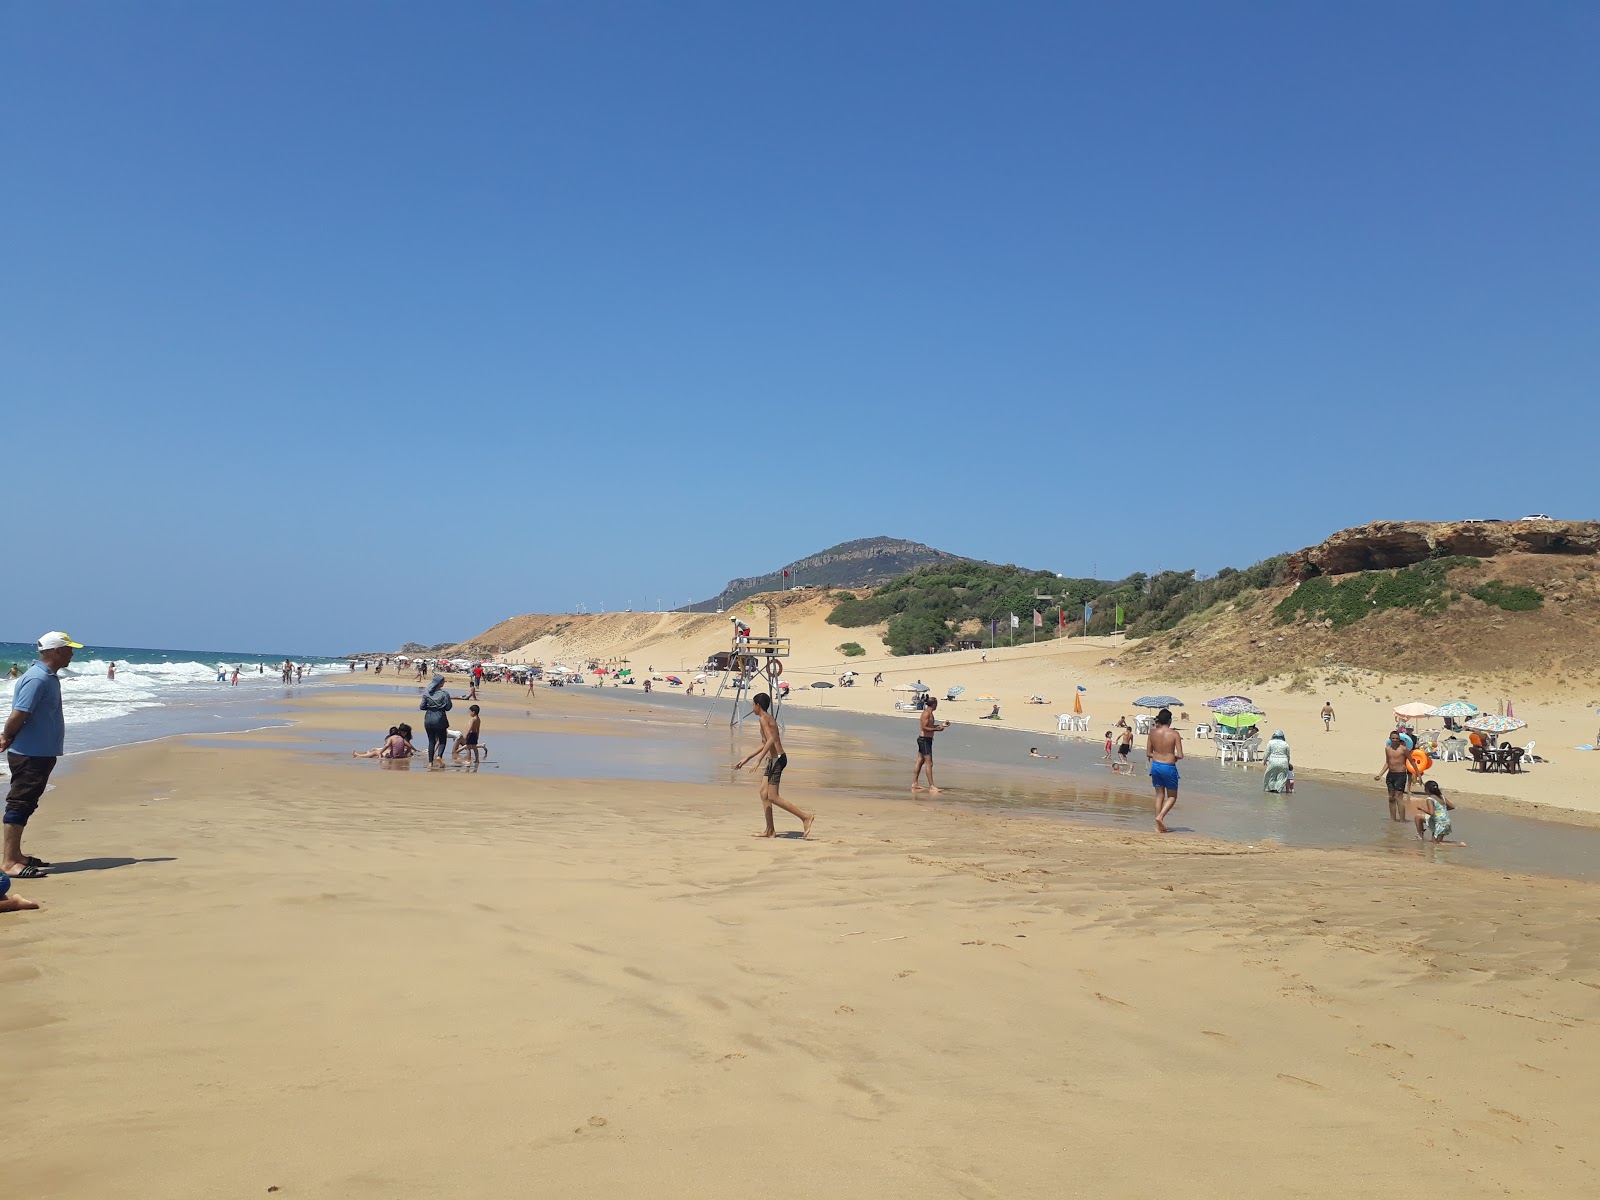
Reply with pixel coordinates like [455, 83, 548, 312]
[298, 688, 1600, 880]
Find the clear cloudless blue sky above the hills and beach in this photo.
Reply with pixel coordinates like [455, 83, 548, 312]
[0, 3, 1600, 653]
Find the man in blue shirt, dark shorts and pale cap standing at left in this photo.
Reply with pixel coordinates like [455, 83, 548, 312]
[0, 632, 83, 878]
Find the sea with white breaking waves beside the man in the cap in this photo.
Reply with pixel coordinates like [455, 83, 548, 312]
[0, 642, 350, 754]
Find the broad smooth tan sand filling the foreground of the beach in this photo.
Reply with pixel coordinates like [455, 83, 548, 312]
[9, 680, 1600, 1198]
